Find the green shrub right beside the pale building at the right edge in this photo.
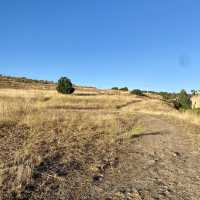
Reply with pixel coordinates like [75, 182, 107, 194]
[174, 90, 192, 110]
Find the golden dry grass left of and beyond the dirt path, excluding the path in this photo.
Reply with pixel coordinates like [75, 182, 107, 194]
[0, 88, 199, 199]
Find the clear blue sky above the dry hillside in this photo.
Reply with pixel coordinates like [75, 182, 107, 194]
[0, 0, 200, 91]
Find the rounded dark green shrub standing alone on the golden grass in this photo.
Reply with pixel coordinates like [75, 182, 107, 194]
[56, 77, 75, 94]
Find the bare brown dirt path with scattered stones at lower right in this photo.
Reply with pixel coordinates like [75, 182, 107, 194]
[96, 114, 200, 200]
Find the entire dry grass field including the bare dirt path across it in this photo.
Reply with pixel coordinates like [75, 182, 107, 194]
[0, 80, 200, 200]
